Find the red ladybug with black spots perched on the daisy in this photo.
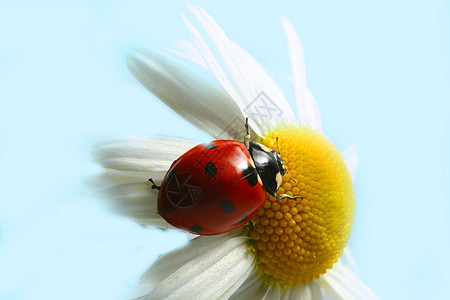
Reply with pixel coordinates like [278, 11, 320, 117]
[149, 118, 301, 235]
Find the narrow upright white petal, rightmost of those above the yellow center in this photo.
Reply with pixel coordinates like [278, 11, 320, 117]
[281, 17, 322, 132]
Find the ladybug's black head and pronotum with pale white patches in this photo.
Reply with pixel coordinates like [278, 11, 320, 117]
[249, 142, 286, 196]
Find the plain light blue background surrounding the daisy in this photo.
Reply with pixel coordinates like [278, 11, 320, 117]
[0, 0, 450, 299]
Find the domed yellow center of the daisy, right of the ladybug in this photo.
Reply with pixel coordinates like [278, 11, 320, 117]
[249, 126, 355, 287]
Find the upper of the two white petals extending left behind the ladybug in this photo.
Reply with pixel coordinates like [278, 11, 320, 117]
[92, 138, 195, 172]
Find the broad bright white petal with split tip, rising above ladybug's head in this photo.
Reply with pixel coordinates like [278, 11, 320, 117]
[184, 5, 295, 135]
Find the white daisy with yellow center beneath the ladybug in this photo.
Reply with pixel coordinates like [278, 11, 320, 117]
[94, 6, 378, 299]
